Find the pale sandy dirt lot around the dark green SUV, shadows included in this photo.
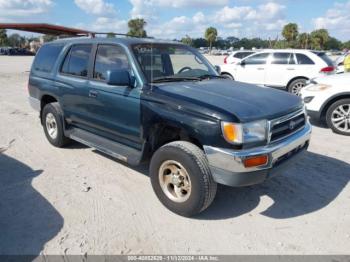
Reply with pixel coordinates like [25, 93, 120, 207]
[0, 56, 350, 254]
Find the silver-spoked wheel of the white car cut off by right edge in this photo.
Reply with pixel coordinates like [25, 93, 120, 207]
[326, 98, 350, 136]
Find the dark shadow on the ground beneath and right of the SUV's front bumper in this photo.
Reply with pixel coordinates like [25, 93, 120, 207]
[195, 152, 350, 220]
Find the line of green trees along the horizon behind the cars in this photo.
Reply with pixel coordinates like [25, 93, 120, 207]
[0, 18, 350, 50]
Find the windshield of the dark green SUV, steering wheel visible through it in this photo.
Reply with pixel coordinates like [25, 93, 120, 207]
[132, 44, 218, 82]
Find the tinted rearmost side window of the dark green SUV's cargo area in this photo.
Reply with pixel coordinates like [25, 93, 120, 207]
[33, 44, 63, 73]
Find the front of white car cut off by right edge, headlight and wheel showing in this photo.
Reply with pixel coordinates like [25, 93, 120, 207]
[300, 73, 350, 136]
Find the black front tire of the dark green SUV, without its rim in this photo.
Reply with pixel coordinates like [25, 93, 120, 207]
[150, 141, 217, 217]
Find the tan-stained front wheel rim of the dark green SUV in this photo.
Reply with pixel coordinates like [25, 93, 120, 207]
[159, 160, 191, 203]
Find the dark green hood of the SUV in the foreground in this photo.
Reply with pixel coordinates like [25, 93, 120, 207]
[157, 79, 302, 122]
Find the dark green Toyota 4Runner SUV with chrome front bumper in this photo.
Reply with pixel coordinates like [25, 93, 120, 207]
[28, 38, 311, 216]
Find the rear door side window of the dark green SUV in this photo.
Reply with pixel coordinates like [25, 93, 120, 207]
[61, 45, 92, 77]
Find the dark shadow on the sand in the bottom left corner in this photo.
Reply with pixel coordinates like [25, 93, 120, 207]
[0, 153, 63, 255]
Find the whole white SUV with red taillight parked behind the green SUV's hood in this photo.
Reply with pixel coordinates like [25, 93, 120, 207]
[220, 49, 335, 94]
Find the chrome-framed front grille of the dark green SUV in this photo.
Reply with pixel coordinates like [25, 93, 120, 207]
[270, 112, 306, 142]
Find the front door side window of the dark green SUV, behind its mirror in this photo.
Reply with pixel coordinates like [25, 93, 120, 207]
[94, 45, 130, 80]
